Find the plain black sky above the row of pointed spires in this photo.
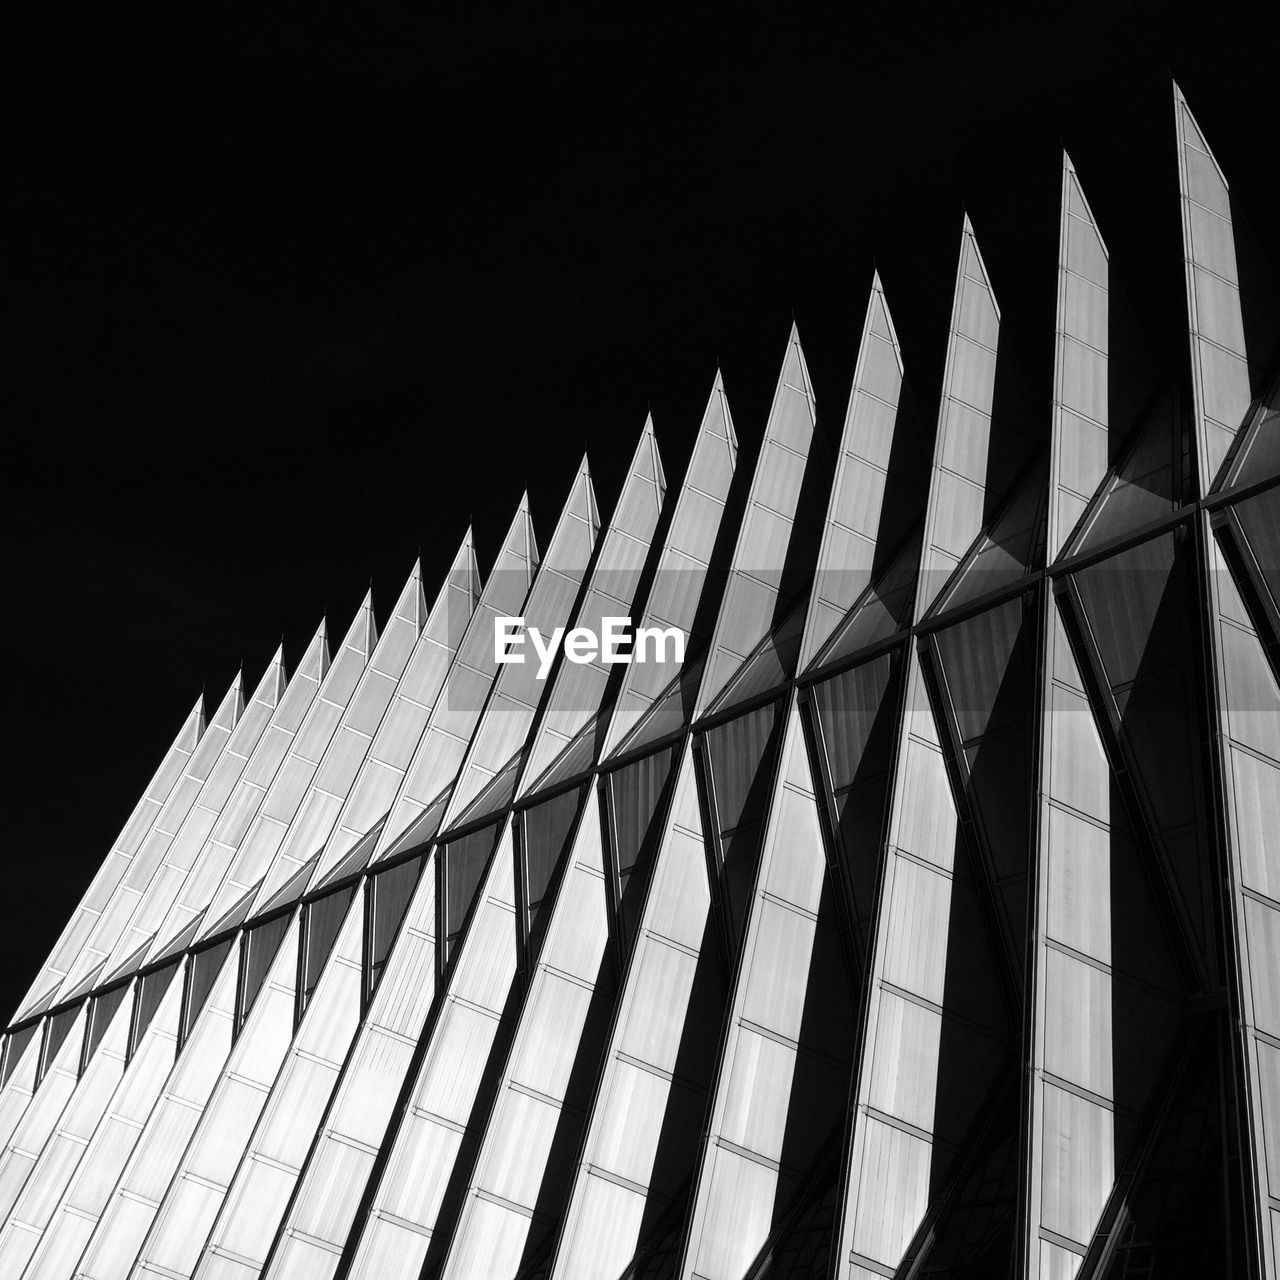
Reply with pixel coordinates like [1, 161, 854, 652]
[0, 3, 1280, 1010]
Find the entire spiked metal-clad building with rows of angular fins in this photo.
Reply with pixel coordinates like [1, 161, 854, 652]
[0, 91, 1280, 1280]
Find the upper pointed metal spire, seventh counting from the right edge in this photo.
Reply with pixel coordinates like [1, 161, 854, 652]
[520, 419, 666, 794]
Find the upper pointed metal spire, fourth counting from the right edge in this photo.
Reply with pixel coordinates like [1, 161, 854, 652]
[800, 271, 920, 669]
